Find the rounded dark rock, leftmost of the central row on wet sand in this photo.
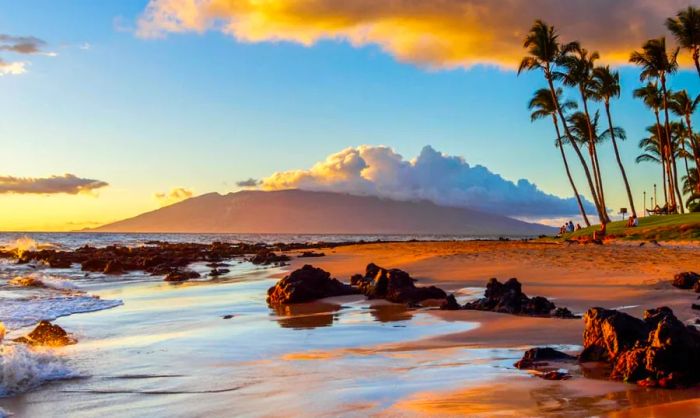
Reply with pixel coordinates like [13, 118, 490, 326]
[267, 264, 359, 305]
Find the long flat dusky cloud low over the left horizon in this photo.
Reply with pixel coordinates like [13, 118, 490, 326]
[0, 174, 109, 194]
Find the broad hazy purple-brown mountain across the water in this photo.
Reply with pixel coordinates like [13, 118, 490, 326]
[94, 190, 554, 236]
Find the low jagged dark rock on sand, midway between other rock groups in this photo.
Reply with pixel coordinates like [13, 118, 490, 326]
[464, 279, 575, 318]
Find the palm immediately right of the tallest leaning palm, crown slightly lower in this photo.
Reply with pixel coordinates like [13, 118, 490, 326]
[554, 42, 609, 221]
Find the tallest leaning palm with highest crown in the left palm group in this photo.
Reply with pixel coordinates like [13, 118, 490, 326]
[518, 20, 607, 223]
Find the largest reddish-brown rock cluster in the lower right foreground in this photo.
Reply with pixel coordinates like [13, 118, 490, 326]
[579, 307, 700, 388]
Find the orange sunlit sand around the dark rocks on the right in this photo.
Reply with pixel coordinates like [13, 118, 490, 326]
[284, 241, 700, 417]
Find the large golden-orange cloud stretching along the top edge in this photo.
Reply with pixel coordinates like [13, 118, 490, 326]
[137, 0, 688, 68]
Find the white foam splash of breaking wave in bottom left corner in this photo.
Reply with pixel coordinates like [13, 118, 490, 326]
[0, 344, 78, 396]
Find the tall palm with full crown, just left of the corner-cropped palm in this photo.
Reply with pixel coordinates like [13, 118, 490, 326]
[630, 37, 684, 212]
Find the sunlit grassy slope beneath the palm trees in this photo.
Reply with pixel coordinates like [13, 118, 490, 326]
[562, 213, 700, 241]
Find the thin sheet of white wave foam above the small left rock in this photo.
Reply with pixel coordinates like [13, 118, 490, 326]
[0, 294, 122, 330]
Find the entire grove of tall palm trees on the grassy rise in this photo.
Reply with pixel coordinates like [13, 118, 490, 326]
[518, 6, 700, 232]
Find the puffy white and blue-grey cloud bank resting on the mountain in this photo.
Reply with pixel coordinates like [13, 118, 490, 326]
[261, 145, 595, 218]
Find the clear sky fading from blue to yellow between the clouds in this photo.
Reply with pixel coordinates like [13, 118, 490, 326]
[0, 0, 700, 229]
